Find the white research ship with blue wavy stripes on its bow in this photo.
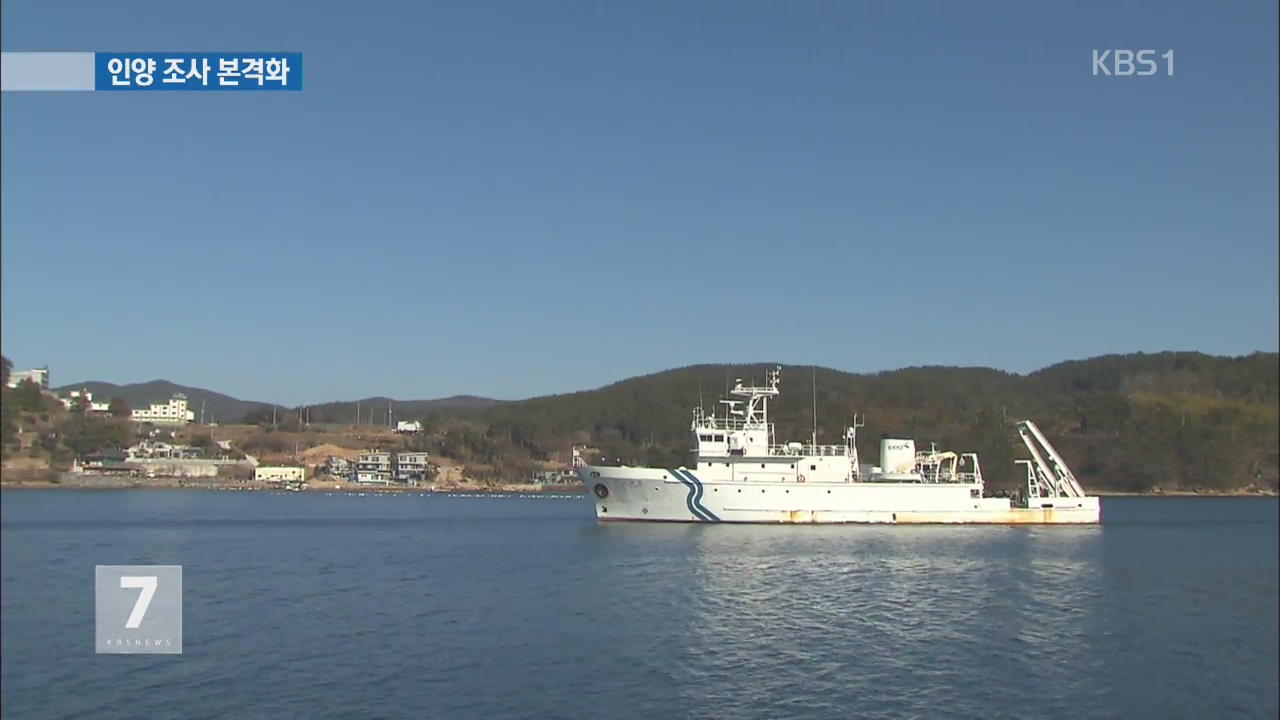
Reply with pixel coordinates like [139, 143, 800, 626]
[577, 366, 1101, 525]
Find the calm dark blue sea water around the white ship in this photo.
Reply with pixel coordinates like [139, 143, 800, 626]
[0, 491, 1277, 719]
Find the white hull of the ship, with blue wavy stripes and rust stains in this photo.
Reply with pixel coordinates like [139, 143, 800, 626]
[579, 466, 1100, 524]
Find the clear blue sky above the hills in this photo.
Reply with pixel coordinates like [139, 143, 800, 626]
[3, 0, 1280, 404]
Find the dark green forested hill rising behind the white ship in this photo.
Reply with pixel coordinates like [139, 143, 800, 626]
[428, 352, 1280, 491]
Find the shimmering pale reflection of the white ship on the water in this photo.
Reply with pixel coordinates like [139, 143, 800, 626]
[581, 524, 1121, 717]
